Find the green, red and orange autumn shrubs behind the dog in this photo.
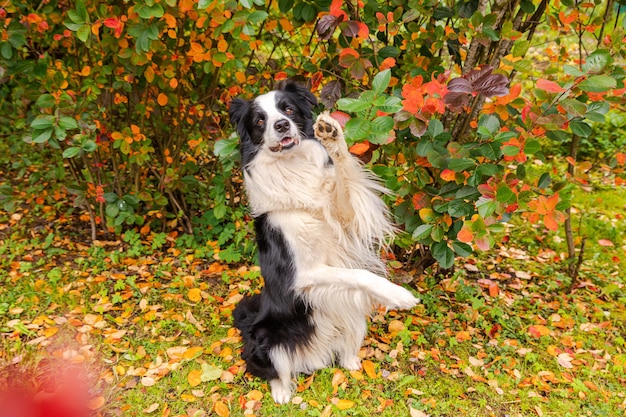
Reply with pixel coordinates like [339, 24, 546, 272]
[0, 0, 626, 268]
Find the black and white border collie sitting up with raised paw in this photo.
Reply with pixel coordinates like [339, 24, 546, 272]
[229, 83, 419, 403]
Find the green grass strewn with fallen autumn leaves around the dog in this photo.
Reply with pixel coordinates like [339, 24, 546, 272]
[0, 160, 626, 417]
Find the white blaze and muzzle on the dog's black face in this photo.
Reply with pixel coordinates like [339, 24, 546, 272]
[255, 91, 299, 152]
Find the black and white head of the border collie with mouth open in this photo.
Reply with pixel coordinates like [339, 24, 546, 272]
[228, 82, 317, 164]
